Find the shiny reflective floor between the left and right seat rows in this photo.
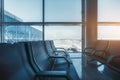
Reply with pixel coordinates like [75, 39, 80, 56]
[70, 53, 120, 80]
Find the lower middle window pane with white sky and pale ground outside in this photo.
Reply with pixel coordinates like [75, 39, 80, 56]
[45, 26, 82, 52]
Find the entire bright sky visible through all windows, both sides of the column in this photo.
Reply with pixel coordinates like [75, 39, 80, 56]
[4, 0, 120, 39]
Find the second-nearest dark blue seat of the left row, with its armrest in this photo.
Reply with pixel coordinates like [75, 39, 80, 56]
[25, 41, 79, 80]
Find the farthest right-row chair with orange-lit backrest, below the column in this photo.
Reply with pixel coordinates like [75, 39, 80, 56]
[83, 40, 109, 66]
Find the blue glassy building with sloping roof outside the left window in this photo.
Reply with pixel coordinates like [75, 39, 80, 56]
[4, 11, 42, 43]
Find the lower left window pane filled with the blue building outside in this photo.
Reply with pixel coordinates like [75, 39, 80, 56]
[4, 25, 42, 43]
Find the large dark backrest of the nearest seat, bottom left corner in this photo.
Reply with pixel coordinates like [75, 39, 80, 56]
[0, 43, 35, 80]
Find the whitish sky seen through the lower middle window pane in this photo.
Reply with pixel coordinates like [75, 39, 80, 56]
[45, 26, 82, 39]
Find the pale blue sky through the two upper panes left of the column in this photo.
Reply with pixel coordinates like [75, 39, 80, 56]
[4, 0, 82, 22]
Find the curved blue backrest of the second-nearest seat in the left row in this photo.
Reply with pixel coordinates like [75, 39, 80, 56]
[30, 41, 54, 71]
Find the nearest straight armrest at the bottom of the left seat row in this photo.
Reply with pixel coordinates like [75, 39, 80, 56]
[36, 71, 68, 77]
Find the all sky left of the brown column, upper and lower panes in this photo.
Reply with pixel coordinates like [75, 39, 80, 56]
[4, 0, 82, 39]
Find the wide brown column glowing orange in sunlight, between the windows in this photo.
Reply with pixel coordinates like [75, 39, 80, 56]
[86, 0, 97, 47]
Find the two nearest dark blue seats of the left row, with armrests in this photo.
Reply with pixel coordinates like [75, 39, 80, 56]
[0, 41, 80, 80]
